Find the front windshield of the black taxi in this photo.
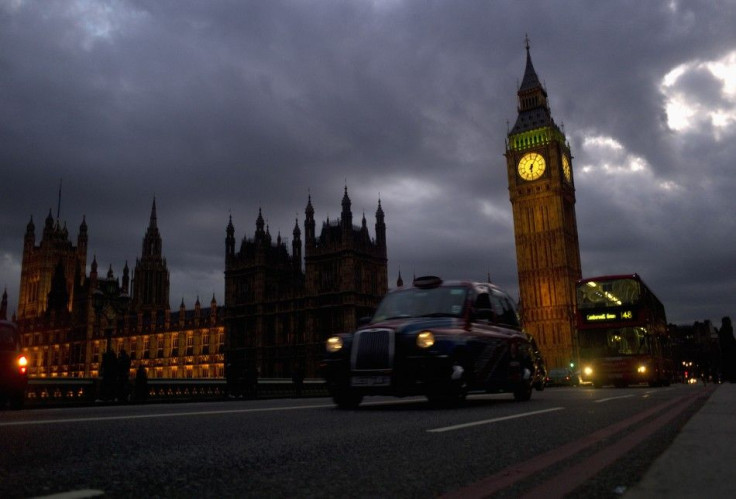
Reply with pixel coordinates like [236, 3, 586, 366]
[372, 286, 468, 322]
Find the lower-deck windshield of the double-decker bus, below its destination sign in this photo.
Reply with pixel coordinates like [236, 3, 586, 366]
[578, 327, 651, 359]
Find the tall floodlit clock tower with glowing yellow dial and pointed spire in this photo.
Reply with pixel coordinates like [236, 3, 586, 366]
[505, 38, 581, 368]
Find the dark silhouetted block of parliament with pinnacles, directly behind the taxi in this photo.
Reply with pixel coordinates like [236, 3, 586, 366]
[225, 187, 388, 378]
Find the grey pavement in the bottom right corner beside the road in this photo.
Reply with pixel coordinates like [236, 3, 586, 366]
[624, 383, 736, 499]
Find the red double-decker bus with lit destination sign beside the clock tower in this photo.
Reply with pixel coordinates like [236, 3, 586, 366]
[576, 274, 674, 387]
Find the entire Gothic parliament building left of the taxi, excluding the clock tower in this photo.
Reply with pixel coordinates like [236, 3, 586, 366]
[10, 187, 387, 378]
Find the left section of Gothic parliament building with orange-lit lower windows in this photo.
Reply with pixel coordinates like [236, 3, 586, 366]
[14, 200, 225, 378]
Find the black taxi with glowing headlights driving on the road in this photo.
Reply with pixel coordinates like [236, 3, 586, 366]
[321, 276, 537, 408]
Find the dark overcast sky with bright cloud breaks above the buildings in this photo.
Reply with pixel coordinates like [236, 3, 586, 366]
[0, 0, 736, 326]
